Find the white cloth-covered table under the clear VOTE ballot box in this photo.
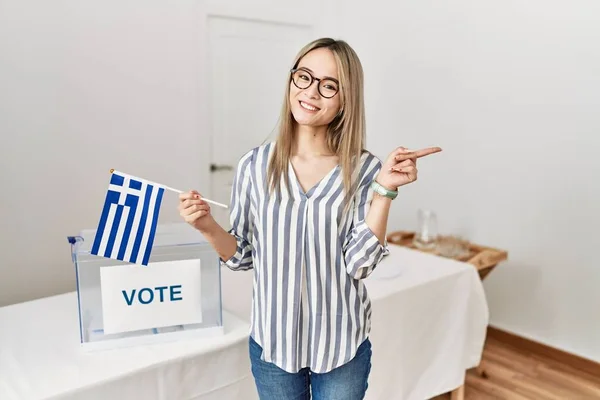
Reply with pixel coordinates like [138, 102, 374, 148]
[0, 293, 255, 400]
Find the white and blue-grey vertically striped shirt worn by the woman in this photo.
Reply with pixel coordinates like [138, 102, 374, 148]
[221, 143, 388, 373]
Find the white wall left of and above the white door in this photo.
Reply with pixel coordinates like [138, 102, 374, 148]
[0, 0, 332, 306]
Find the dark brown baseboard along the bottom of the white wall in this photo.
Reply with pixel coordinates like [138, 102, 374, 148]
[487, 325, 600, 376]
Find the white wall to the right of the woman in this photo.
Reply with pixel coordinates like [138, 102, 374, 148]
[340, 0, 600, 361]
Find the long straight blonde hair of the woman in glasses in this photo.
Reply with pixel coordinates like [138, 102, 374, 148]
[267, 38, 366, 205]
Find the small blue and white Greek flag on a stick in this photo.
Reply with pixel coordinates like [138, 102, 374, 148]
[91, 171, 165, 265]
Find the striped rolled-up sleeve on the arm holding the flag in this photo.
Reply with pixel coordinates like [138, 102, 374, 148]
[221, 152, 253, 271]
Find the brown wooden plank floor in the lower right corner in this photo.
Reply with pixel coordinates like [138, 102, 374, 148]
[434, 337, 600, 400]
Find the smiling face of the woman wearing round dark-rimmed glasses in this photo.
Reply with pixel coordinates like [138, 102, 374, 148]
[289, 48, 341, 127]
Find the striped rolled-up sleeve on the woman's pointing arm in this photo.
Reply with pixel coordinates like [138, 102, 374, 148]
[343, 156, 389, 279]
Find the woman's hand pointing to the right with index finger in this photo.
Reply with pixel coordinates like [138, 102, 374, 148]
[376, 147, 442, 190]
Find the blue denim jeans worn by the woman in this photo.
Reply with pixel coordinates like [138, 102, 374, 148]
[249, 337, 371, 400]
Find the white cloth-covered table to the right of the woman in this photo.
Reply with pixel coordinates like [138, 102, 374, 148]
[366, 246, 489, 400]
